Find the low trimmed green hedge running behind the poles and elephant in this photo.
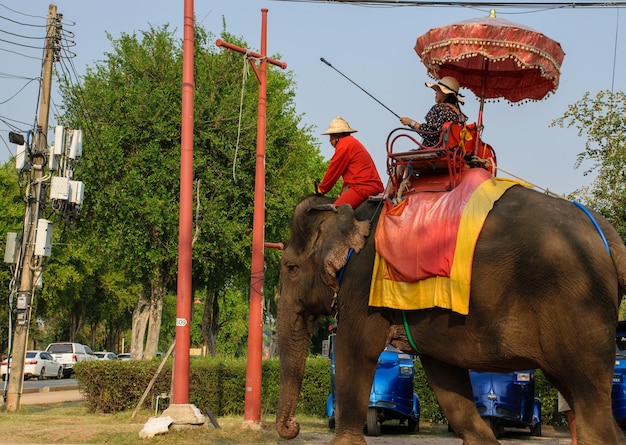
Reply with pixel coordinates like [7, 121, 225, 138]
[74, 357, 563, 425]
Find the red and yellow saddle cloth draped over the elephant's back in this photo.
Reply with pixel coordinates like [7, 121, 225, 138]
[370, 168, 518, 314]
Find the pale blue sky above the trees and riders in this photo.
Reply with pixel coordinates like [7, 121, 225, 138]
[0, 0, 626, 194]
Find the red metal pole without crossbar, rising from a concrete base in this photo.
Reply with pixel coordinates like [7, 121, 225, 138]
[172, 0, 194, 405]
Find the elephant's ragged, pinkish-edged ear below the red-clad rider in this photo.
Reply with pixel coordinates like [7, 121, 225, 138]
[319, 204, 370, 292]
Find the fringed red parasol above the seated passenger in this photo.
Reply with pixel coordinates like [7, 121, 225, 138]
[415, 10, 565, 125]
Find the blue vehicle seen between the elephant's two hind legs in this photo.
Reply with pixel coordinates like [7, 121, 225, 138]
[470, 370, 541, 437]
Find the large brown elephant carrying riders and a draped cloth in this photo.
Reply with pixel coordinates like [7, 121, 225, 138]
[276, 191, 626, 445]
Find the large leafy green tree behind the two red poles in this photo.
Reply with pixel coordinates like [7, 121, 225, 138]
[57, 23, 325, 358]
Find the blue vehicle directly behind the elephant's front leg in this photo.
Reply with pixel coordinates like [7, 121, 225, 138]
[326, 335, 420, 436]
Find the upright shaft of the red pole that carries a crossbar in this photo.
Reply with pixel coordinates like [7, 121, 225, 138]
[244, 8, 267, 422]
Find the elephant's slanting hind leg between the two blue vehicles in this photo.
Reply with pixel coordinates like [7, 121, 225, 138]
[421, 356, 500, 445]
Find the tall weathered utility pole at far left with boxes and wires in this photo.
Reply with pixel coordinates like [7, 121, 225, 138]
[6, 4, 58, 412]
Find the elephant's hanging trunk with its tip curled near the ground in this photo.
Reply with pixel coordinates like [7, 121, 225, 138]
[276, 305, 310, 439]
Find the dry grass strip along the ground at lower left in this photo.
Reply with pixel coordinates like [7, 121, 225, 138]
[0, 402, 332, 445]
